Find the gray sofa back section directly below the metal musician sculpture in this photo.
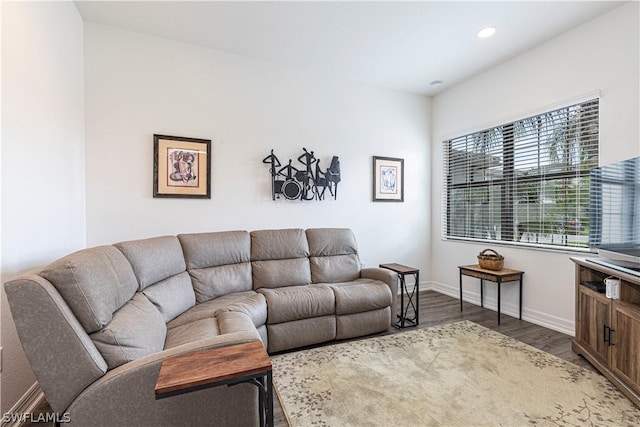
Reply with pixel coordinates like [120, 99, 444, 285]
[251, 229, 311, 289]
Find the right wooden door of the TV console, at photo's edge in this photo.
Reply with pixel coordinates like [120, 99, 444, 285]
[611, 302, 640, 393]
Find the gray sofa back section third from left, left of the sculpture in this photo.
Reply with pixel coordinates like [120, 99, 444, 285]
[178, 231, 252, 303]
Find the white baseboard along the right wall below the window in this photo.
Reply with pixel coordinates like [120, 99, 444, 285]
[420, 282, 575, 337]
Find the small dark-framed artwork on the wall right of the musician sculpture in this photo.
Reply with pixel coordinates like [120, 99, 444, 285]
[373, 156, 404, 202]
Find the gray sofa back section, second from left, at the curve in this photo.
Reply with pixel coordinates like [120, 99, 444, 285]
[114, 236, 196, 322]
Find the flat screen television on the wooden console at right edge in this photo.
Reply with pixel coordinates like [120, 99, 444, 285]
[589, 157, 640, 275]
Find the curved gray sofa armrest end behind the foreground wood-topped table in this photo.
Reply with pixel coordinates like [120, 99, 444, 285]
[66, 332, 258, 426]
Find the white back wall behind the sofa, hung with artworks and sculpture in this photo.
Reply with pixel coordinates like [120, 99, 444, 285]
[85, 23, 431, 277]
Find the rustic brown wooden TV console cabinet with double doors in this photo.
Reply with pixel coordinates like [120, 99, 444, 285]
[571, 258, 640, 406]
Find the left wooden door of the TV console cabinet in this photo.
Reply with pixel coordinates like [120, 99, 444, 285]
[576, 286, 610, 363]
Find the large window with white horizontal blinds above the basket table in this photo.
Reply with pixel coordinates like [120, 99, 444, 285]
[443, 98, 599, 248]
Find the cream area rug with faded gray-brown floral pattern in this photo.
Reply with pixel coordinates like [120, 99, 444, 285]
[272, 321, 640, 427]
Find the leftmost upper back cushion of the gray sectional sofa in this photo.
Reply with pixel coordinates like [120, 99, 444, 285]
[40, 246, 138, 333]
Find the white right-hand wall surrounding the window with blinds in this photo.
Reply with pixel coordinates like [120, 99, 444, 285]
[431, 2, 640, 333]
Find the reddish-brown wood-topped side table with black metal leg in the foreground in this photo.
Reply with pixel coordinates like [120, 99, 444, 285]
[155, 341, 273, 427]
